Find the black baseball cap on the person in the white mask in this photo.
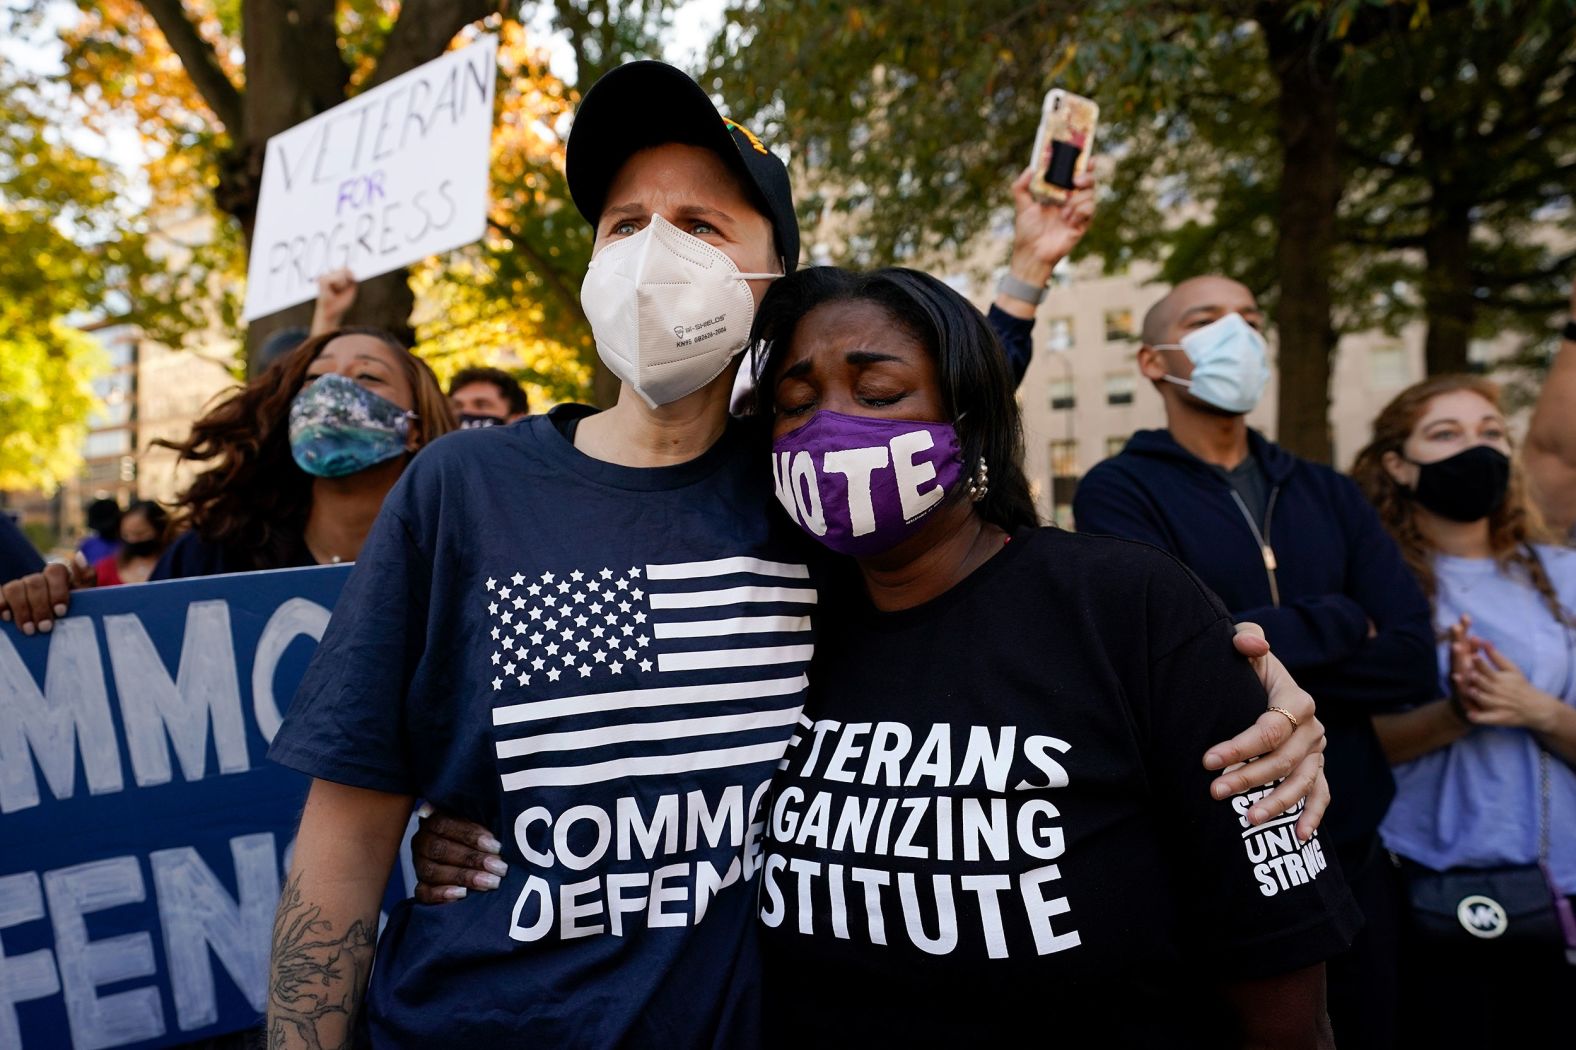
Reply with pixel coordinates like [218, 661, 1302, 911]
[564, 60, 799, 273]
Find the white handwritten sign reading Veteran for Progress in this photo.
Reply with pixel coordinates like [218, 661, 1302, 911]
[244, 36, 498, 320]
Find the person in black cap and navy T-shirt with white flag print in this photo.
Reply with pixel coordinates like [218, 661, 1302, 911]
[269, 61, 1322, 1047]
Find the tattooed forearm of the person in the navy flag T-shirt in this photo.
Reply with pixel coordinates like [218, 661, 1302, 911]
[268, 873, 375, 1050]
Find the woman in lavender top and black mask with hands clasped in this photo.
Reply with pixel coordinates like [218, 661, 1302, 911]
[1352, 375, 1576, 1048]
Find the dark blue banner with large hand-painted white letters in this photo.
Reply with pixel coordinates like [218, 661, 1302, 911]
[0, 566, 410, 1050]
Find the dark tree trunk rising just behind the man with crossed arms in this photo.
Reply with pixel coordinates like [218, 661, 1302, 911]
[1256, 3, 1341, 464]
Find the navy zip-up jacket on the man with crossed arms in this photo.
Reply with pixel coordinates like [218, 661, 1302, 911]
[1073, 430, 1439, 847]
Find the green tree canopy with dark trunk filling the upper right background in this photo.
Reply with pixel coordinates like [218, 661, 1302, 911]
[708, 0, 1576, 457]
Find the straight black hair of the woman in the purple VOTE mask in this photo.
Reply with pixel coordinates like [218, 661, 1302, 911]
[750, 266, 1040, 533]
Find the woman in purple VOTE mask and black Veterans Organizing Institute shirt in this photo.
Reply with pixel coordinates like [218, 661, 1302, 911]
[755, 270, 1357, 1047]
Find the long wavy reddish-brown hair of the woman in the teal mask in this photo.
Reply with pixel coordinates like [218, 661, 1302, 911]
[158, 328, 454, 569]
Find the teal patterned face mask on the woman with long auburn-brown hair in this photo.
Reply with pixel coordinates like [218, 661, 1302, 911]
[290, 375, 416, 478]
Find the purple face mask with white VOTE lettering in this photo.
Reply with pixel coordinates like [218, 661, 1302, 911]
[772, 411, 963, 558]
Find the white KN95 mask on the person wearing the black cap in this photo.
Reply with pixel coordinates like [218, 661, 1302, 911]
[580, 214, 782, 408]
